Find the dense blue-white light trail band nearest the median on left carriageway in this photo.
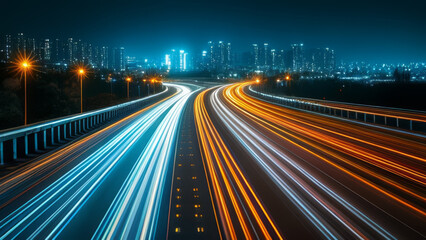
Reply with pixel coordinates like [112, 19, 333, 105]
[93, 83, 198, 239]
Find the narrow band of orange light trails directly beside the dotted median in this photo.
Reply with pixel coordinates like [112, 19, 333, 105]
[194, 90, 283, 239]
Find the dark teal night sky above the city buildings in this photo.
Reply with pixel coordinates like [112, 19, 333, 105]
[0, 0, 426, 63]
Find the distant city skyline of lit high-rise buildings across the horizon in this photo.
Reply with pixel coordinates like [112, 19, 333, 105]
[0, 33, 426, 81]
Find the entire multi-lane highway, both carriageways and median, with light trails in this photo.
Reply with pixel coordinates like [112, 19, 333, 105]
[0, 81, 426, 239]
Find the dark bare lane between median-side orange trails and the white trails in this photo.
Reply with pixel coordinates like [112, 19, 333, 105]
[204, 91, 319, 239]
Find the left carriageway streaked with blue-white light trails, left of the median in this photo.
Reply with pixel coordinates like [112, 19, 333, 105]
[0, 84, 200, 239]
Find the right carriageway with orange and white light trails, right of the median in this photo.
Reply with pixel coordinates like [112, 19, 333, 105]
[194, 83, 426, 239]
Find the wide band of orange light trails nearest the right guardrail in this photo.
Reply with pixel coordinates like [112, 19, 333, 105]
[224, 83, 426, 216]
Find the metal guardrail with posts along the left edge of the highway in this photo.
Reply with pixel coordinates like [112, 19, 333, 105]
[0, 86, 168, 165]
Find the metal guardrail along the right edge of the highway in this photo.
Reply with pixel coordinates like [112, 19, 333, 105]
[248, 85, 426, 132]
